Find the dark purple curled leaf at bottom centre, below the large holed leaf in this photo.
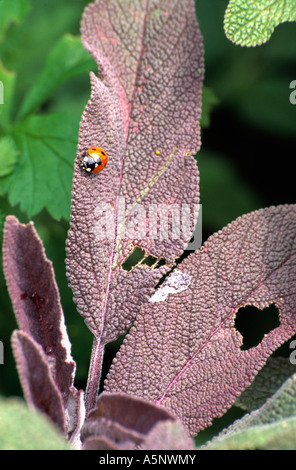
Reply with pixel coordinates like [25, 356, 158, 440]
[81, 393, 194, 450]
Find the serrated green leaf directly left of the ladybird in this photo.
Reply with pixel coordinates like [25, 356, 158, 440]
[0, 113, 79, 219]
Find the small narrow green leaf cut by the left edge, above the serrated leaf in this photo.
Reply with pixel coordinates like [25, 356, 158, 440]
[0, 61, 16, 132]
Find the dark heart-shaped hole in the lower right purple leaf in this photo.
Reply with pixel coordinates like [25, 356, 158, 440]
[234, 304, 280, 351]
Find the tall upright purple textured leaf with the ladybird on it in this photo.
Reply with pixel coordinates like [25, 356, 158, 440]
[67, 0, 203, 343]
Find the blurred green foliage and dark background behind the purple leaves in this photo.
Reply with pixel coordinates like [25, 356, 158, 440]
[0, 0, 296, 448]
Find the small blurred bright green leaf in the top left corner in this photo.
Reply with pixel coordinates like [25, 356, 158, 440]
[0, 0, 30, 41]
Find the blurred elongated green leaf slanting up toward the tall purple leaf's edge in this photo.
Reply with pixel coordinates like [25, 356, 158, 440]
[18, 34, 94, 119]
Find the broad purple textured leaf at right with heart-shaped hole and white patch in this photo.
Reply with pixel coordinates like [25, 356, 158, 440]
[106, 205, 296, 434]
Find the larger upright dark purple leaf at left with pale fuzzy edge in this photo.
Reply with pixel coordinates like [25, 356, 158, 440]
[3, 216, 75, 404]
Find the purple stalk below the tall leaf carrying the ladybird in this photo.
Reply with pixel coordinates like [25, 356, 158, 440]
[85, 337, 104, 416]
